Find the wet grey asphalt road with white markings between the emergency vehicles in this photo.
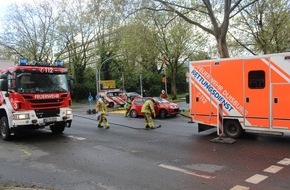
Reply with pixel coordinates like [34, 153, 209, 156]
[0, 103, 290, 190]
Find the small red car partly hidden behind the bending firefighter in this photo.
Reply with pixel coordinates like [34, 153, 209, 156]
[130, 97, 180, 119]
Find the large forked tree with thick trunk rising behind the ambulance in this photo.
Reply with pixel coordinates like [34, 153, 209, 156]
[149, 0, 258, 58]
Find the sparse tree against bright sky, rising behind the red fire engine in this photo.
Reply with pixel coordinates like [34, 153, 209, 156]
[0, 1, 59, 62]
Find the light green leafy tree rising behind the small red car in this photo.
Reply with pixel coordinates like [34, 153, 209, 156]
[117, 20, 160, 93]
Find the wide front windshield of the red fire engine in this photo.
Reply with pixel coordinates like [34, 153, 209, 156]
[16, 73, 69, 93]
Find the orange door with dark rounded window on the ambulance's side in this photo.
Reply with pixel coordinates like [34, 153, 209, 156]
[243, 57, 270, 128]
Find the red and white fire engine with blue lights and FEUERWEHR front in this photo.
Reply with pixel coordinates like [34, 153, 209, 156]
[0, 59, 73, 140]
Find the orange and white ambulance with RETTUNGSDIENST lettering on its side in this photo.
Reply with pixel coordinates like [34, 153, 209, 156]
[189, 53, 290, 138]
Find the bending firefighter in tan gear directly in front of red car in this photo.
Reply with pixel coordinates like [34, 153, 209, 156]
[141, 99, 156, 129]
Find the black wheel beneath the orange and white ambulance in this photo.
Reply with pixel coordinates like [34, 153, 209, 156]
[224, 120, 243, 139]
